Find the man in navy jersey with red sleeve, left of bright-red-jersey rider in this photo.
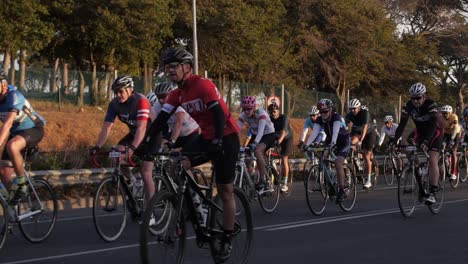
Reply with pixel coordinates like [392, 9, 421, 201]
[89, 76, 150, 188]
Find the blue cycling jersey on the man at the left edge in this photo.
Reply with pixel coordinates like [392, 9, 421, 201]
[0, 85, 45, 136]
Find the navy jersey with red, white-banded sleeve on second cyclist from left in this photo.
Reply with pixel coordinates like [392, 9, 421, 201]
[104, 93, 150, 135]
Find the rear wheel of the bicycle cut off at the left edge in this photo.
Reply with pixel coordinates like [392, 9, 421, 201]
[18, 178, 58, 243]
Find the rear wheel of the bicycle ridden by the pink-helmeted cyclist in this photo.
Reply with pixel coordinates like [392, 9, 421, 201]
[258, 165, 280, 213]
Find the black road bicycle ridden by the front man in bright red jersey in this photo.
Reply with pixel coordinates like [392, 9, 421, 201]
[140, 152, 253, 264]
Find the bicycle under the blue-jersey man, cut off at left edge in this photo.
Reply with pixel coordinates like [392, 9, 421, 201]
[0, 146, 58, 249]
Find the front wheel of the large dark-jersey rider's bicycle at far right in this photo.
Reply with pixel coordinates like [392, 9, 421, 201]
[397, 167, 419, 217]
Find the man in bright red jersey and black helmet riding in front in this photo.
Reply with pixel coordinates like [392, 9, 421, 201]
[147, 48, 240, 263]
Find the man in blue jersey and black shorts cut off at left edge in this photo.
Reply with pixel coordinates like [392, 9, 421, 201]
[0, 72, 45, 205]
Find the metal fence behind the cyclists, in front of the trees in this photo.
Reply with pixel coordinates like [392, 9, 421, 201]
[10, 67, 405, 128]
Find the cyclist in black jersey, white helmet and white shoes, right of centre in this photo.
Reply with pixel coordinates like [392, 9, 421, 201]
[346, 99, 377, 188]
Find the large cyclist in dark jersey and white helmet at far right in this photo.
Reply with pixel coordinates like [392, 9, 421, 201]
[391, 83, 444, 204]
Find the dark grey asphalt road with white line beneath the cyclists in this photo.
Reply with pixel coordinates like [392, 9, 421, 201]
[0, 176, 468, 264]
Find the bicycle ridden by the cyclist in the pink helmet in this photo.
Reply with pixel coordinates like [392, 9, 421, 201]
[234, 147, 279, 213]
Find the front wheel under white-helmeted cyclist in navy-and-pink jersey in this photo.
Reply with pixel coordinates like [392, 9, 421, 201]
[305, 165, 328, 216]
